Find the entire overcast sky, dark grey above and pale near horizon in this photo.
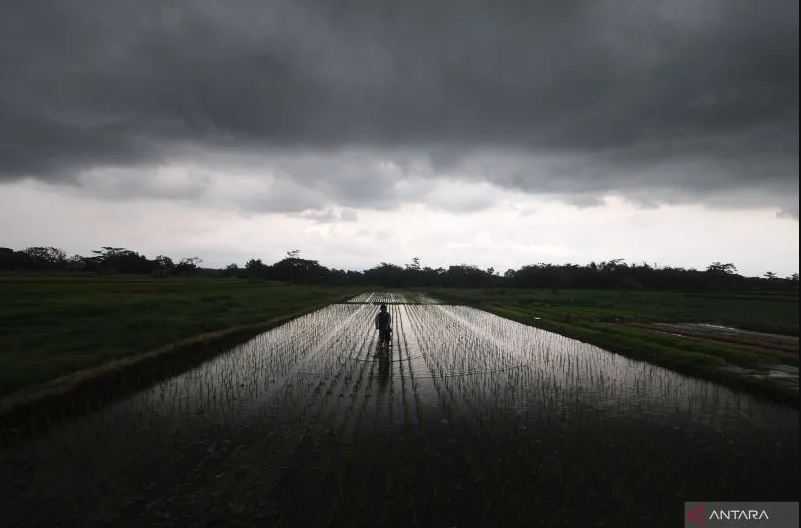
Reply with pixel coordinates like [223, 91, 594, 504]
[0, 0, 799, 275]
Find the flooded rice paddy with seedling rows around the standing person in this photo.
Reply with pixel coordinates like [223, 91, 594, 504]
[0, 293, 799, 527]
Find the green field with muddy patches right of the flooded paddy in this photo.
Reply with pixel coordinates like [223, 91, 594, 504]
[428, 289, 799, 406]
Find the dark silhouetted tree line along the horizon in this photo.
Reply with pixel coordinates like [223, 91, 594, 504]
[0, 246, 798, 290]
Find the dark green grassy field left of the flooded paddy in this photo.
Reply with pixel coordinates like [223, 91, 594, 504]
[0, 274, 356, 395]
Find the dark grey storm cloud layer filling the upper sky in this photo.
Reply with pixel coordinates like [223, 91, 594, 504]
[0, 0, 798, 217]
